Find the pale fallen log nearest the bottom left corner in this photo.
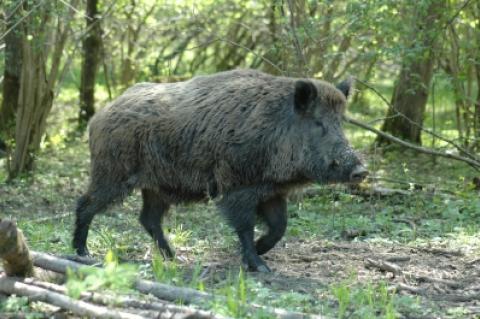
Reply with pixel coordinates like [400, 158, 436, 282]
[0, 275, 146, 319]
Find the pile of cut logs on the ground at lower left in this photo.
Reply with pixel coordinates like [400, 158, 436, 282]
[0, 220, 321, 319]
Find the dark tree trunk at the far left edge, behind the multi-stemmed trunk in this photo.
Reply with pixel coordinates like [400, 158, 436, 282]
[0, 1, 22, 141]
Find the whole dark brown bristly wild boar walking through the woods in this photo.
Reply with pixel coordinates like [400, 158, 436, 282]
[73, 70, 368, 272]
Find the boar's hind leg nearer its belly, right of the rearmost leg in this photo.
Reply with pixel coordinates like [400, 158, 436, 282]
[140, 189, 174, 259]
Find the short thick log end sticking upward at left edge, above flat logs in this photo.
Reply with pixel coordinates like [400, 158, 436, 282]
[0, 220, 33, 277]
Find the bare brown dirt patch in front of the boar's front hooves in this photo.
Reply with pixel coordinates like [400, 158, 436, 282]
[193, 240, 480, 318]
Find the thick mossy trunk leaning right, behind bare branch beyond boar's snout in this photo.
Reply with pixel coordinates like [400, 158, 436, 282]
[377, 0, 445, 144]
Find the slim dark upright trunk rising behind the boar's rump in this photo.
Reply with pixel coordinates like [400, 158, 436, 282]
[78, 0, 102, 129]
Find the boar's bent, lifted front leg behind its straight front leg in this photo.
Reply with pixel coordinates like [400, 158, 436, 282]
[256, 196, 287, 255]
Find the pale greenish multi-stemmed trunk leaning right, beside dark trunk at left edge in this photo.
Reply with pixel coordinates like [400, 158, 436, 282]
[9, 0, 77, 179]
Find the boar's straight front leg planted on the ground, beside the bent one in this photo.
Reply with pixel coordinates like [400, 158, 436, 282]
[218, 188, 271, 272]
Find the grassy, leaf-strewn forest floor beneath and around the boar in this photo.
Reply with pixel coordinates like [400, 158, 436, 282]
[0, 114, 480, 318]
